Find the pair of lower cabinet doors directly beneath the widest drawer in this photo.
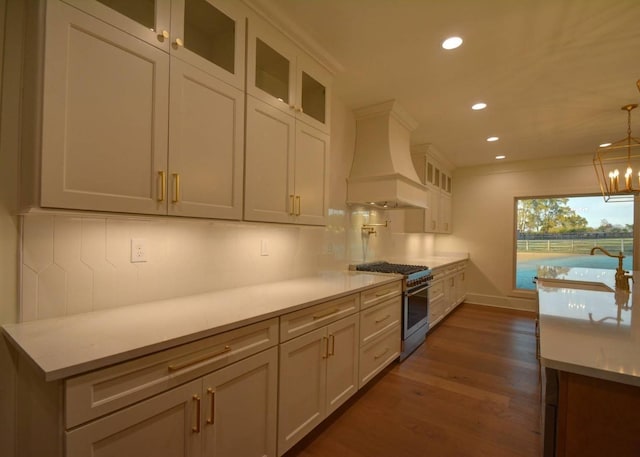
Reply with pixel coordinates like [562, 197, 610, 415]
[65, 348, 277, 457]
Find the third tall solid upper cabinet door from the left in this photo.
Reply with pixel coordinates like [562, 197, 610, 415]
[244, 96, 295, 222]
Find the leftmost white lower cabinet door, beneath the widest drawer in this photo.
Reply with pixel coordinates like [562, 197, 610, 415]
[65, 380, 203, 457]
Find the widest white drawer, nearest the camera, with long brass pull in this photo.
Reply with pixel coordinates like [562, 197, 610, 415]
[65, 318, 278, 428]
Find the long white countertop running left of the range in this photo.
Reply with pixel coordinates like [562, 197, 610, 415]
[2, 272, 400, 381]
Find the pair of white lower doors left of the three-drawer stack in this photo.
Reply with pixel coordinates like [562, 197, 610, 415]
[278, 314, 359, 455]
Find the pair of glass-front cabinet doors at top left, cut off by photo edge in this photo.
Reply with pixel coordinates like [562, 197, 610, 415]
[63, 0, 246, 88]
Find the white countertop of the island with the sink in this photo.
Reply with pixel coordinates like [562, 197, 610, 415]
[538, 267, 640, 386]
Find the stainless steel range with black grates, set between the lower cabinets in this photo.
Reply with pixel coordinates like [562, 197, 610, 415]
[355, 262, 433, 360]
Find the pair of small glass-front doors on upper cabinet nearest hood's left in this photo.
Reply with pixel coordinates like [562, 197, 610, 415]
[247, 19, 331, 132]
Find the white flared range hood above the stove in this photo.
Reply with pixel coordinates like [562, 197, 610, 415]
[347, 100, 427, 209]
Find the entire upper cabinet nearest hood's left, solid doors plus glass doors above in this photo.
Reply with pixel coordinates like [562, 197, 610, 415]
[244, 18, 330, 225]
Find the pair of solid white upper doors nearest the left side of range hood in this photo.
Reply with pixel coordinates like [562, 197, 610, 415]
[244, 96, 329, 225]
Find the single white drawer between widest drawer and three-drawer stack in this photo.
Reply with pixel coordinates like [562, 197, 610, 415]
[280, 294, 360, 342]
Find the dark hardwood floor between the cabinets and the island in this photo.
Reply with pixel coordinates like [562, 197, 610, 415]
[286, 304, 540, 457]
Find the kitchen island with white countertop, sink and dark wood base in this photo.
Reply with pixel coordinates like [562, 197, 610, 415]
[537, 267, 640, 457]
